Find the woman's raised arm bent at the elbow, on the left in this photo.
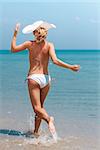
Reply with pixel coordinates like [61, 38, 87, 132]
[11, 24, 30, 52]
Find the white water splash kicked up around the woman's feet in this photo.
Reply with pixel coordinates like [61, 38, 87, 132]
[24, 113, 60, 146]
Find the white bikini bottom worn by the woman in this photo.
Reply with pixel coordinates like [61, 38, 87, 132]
[27, 74, 51, 88]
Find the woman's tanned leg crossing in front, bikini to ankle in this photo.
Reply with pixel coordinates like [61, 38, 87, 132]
[28, 79, 50, 123]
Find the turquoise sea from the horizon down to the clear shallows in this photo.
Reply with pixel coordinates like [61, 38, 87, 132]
[0, 50, 100, 150]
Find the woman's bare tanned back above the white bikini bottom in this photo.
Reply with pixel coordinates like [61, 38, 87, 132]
[28, 41, 49, 75]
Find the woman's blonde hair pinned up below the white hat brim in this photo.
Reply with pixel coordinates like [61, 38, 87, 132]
[33, 27, 47, 43]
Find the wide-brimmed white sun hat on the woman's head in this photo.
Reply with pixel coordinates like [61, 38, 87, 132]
[22, 20, 56, 34]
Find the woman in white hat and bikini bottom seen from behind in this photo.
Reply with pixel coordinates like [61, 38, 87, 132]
[11, 21, 80, 137]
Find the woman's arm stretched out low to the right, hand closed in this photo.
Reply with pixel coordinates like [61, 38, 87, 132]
[49, 43, 80, 71]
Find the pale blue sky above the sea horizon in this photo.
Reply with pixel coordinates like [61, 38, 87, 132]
[0, 0, 100, 50]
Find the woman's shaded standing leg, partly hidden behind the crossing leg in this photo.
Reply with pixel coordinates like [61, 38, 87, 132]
[34, 84, 50, 134]
